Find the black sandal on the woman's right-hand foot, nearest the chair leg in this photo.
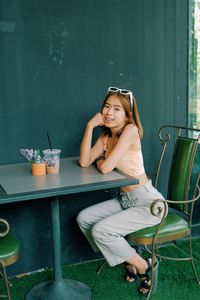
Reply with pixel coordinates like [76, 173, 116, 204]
[138, 258, 156, 297]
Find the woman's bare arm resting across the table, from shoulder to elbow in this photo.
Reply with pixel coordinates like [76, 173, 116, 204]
[97, 124, 141, 174]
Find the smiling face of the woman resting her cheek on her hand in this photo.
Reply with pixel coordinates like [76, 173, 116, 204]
[102, 94, 127, 130]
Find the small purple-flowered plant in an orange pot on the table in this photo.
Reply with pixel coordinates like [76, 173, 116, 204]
[20, 149, 46, 176]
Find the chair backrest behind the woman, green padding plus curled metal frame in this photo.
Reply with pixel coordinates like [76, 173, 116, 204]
[155, 125, 200, 212]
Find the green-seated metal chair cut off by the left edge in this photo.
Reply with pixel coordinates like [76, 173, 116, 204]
[0, 219, 19, 300]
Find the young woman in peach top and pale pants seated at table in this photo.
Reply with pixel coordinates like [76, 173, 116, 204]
[77, 87, 163, 295]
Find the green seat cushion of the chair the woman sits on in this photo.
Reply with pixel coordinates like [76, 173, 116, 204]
[126, 213, 190, 245]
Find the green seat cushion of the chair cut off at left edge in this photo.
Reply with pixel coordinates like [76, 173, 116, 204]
[0, 231, 19, 264]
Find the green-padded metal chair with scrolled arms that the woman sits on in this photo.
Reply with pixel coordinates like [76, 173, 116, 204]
[126, 125, 200, 299]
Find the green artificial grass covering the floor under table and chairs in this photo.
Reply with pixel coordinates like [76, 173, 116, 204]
[0, 239, 200, 300]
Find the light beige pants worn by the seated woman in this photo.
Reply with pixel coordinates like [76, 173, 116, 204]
[77, 181, 164, 266]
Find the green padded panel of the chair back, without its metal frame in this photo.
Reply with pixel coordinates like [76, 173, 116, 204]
[167, 136, 198, 212]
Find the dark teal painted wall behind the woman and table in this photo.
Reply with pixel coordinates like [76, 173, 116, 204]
[0, 0, 192, 272]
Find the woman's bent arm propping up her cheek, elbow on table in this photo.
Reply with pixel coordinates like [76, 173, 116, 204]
[79, 113, 103, 167]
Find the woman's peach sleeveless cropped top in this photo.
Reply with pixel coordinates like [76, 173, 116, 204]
[103, 135, 145, 177]
